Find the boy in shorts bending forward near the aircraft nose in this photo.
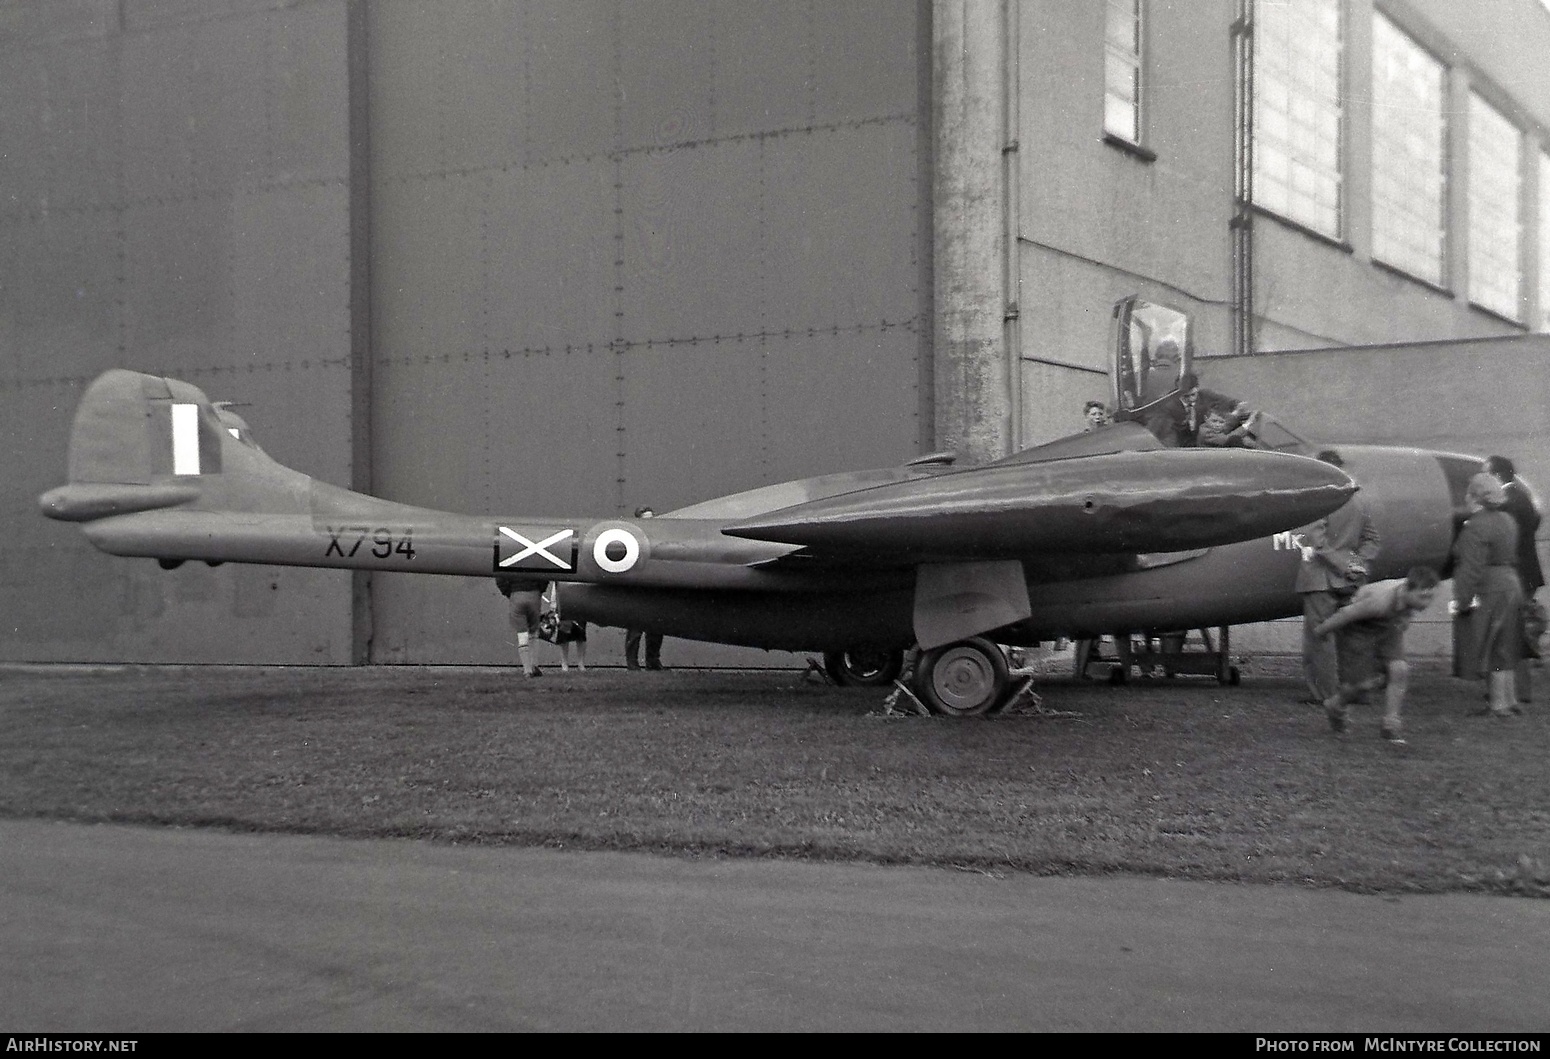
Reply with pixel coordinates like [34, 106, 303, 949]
[1314, 566, 1438, 744]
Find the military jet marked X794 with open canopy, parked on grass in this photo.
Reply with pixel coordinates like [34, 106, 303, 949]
[40, 299, 1479, 715]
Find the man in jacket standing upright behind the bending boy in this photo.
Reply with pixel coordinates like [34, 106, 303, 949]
[1293, 448, 1383, 704]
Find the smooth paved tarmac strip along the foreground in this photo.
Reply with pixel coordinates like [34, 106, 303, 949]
[0, 820, 1550, 1034]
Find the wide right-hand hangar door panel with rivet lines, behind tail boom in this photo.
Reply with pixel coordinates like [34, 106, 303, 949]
[359, 0, 932, 664]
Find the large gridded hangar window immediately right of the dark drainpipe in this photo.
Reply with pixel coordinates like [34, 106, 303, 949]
[1254, 0, 1342, 239]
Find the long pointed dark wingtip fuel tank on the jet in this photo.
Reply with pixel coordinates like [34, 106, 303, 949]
[724, 450, 1356, 557]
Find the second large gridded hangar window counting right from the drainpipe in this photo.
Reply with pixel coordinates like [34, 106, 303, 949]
[1372, 14, 1448, 285]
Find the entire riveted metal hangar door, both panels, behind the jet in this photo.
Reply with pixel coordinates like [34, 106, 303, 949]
[0, 0, 932, 664]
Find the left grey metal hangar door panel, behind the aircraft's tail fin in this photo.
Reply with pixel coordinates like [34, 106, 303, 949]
[0, 0, 352, 662]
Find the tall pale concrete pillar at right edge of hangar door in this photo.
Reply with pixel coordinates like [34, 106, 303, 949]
[932, 0, 1012, 461]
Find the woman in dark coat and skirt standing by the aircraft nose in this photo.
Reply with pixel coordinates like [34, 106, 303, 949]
[1454, 471, 1524, 716]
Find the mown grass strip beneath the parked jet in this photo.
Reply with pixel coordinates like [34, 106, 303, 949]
[0, 665, 1550, 896]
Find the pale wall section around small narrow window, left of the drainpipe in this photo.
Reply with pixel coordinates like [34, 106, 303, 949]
[1018, 0, 1232, 443]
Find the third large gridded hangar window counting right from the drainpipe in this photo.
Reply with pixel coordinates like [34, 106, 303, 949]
[1469, 93, 1521, 319]
